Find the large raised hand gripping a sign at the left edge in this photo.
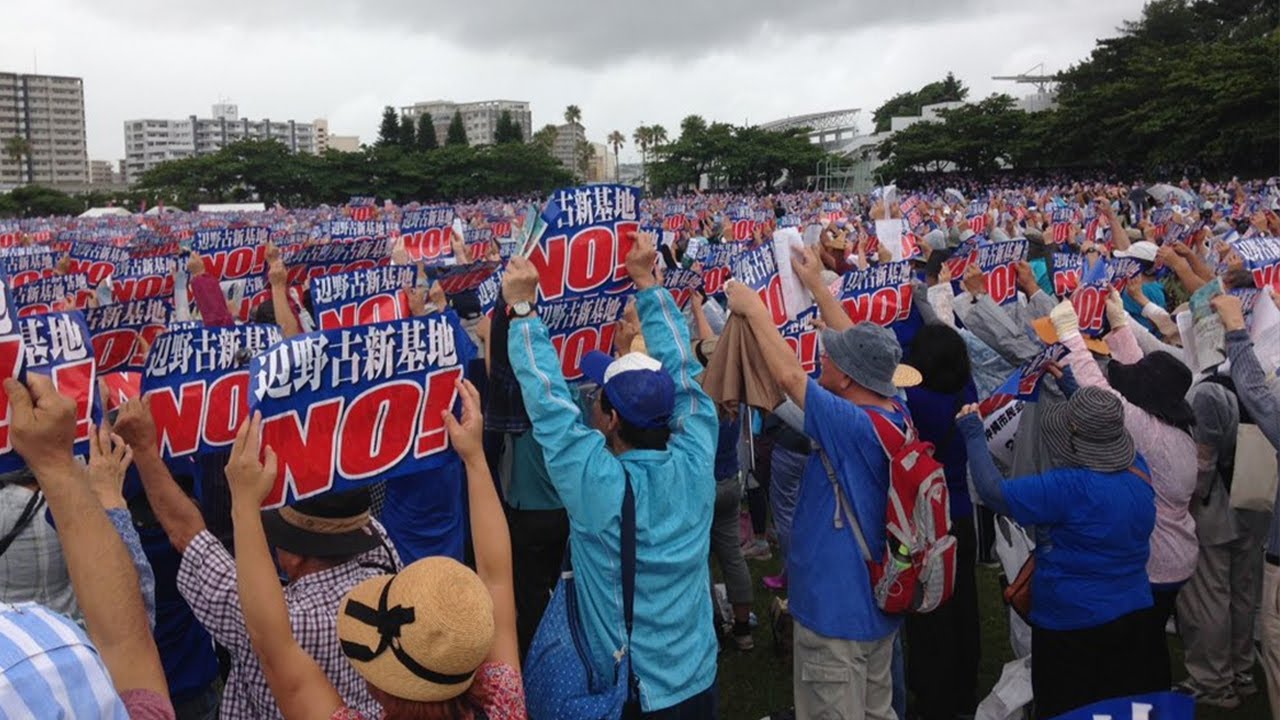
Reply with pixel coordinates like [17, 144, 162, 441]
[4, 373, 76, 480]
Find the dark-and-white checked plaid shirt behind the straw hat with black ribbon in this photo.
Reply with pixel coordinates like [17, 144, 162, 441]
[178, 521, 399, 720]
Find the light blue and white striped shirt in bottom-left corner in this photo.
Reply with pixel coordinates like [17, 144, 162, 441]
[0, 602, 129, 720]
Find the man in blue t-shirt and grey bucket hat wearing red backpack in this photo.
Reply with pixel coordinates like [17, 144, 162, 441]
[726, 244, 920, 720]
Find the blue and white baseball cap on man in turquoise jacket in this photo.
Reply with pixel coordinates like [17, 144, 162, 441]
[580, 350, 676, 428]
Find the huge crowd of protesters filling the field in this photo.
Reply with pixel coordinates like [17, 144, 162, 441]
[0, 177, 1280, 720]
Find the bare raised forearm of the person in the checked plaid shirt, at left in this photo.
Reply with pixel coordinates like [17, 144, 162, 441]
[115, 398, 205, 552]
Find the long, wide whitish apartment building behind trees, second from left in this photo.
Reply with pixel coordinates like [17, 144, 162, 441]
[124, 102, 317, 182]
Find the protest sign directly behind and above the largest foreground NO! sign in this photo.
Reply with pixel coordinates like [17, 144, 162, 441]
[311, 265, 417, 331]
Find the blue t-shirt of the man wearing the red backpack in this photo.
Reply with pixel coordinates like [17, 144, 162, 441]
[787, 379, 904, 642]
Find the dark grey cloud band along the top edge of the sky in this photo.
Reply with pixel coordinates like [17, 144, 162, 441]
[64, 0, 993, 68]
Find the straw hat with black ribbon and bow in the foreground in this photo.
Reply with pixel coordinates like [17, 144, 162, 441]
[338, 557, 494, 702]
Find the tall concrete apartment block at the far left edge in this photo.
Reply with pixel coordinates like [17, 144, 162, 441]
[0, 73, 88, 187]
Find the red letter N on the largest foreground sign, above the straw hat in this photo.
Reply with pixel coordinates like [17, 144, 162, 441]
[262, 397, 342, 507]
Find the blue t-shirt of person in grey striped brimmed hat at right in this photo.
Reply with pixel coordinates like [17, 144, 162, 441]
[1001, 459, 1156, 630]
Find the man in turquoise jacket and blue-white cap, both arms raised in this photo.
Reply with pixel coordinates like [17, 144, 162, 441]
[502, 236, 717, 719]
